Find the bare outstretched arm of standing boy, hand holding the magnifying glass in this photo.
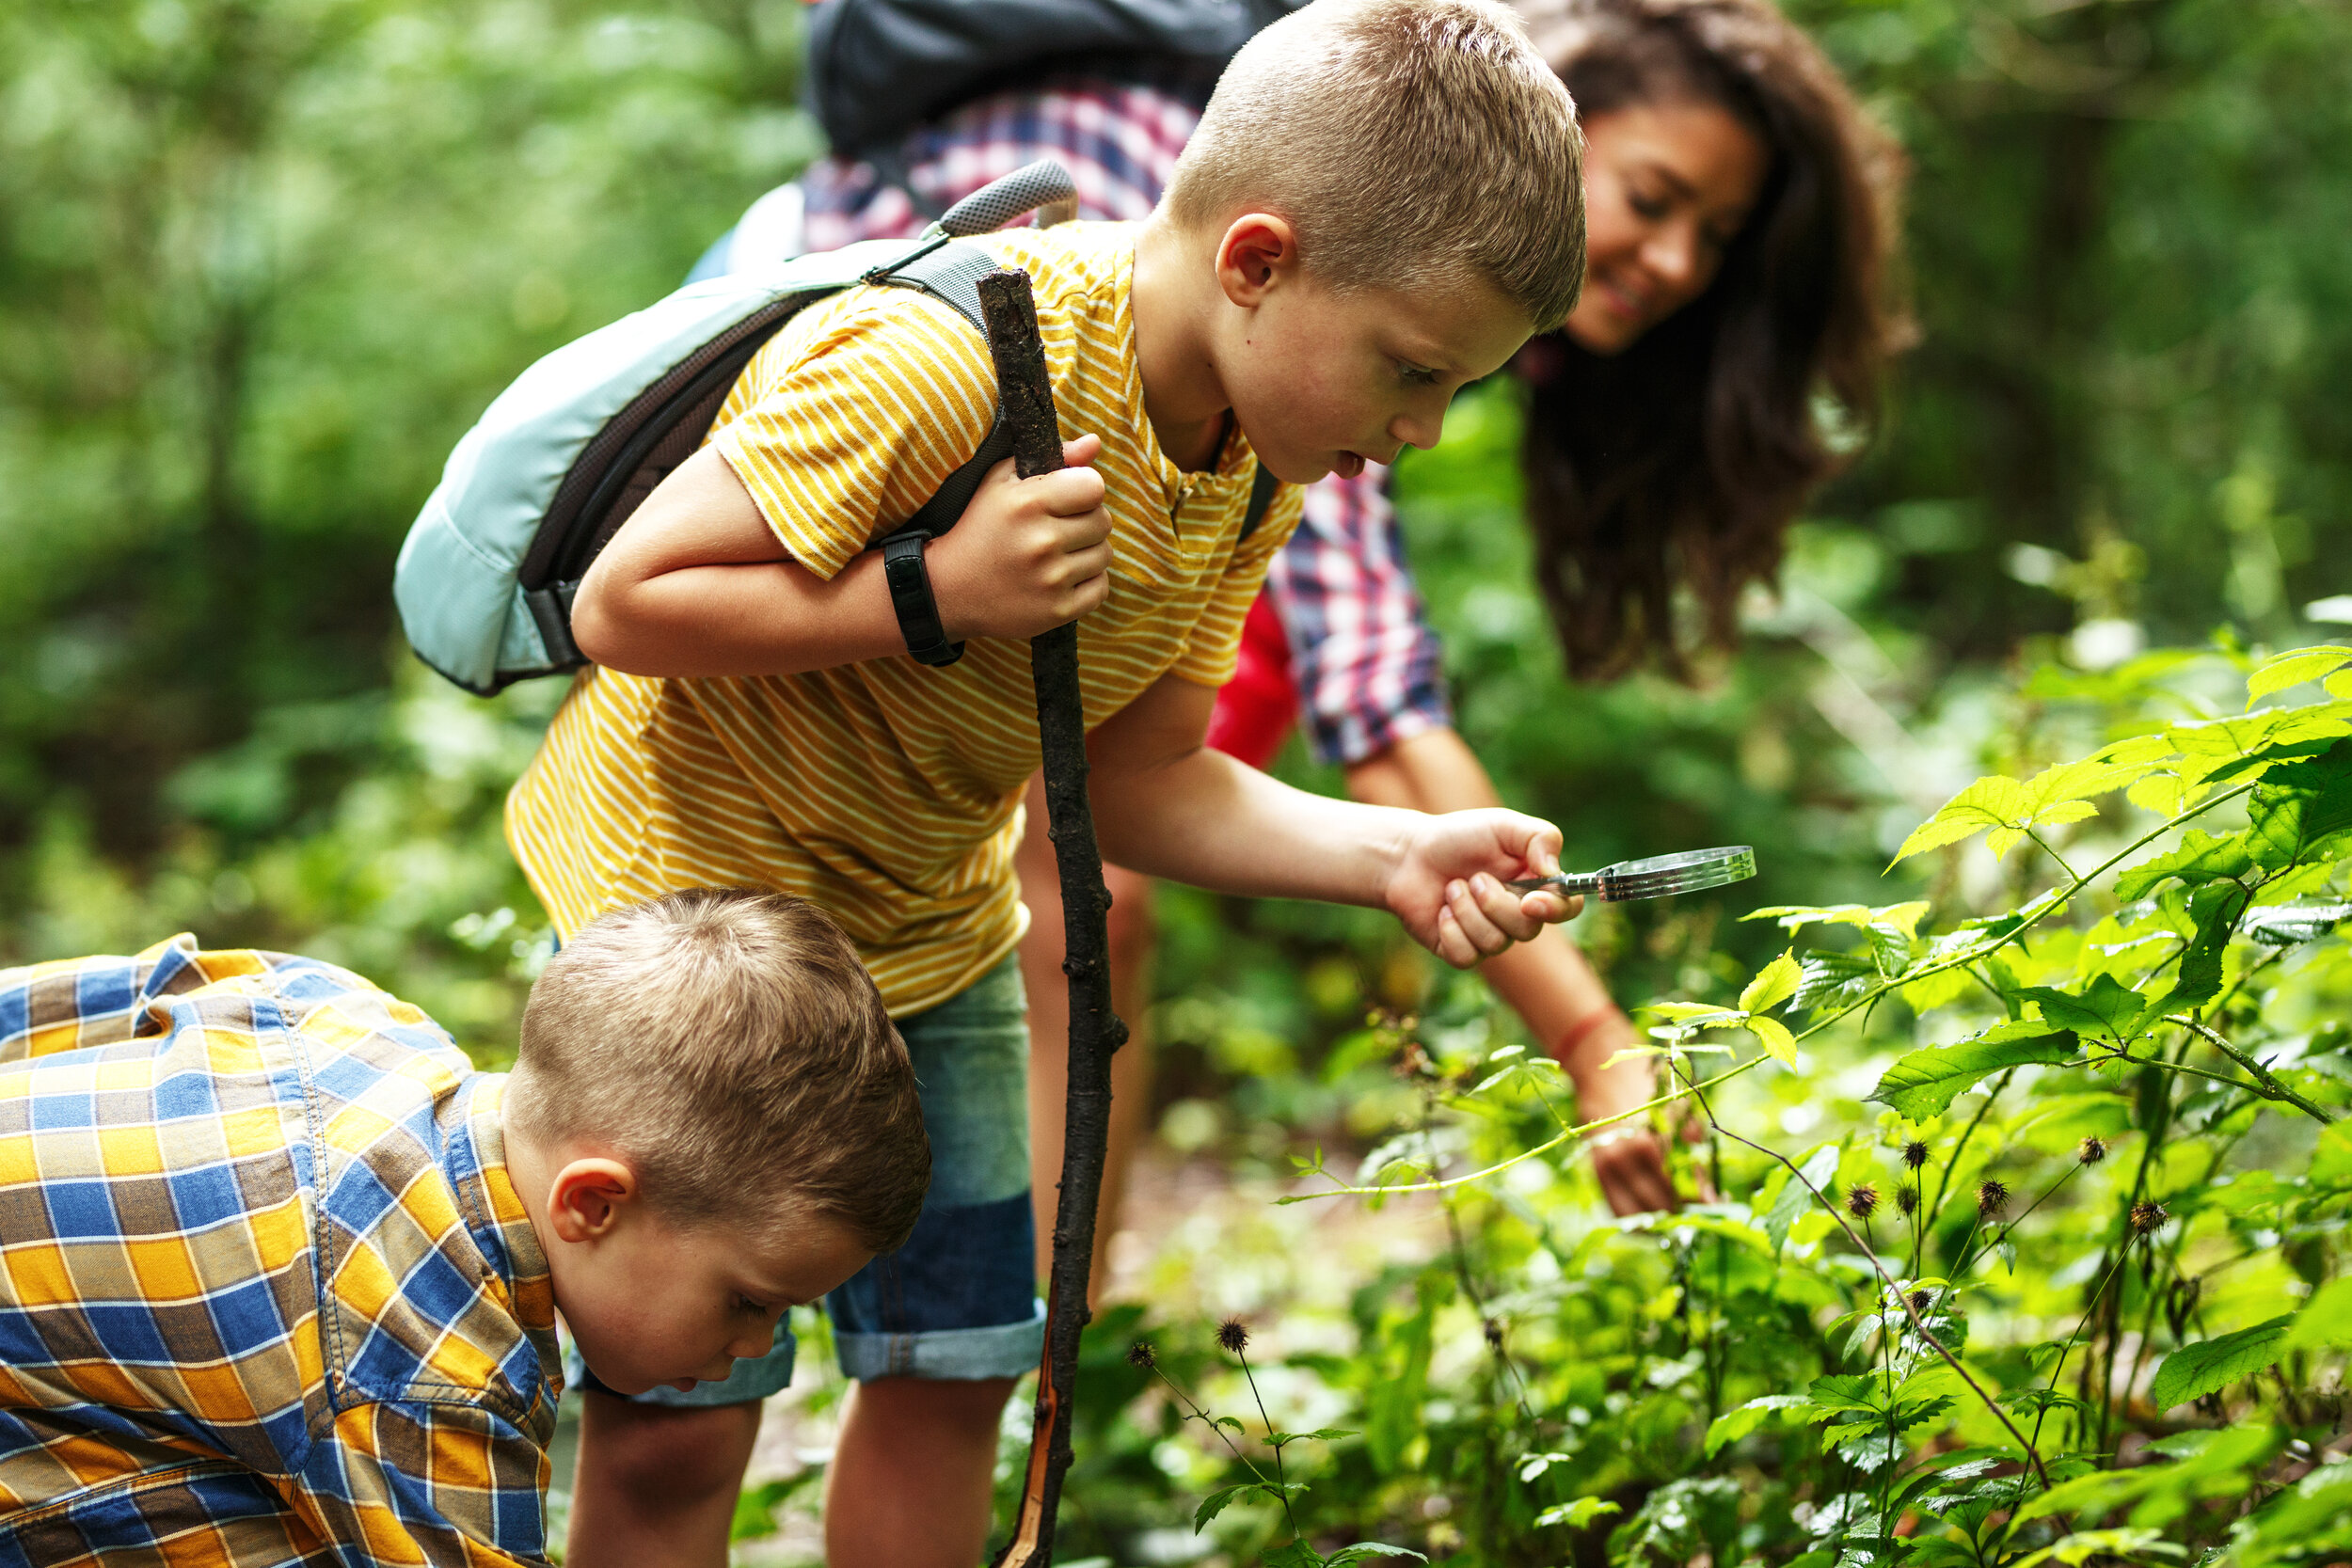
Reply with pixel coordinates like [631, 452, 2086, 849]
[1087, 674, 1583, 969]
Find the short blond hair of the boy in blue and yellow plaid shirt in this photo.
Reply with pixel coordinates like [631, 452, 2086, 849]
[511, 889, 931, 1253]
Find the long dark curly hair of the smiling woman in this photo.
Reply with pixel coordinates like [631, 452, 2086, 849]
[1519, 0, 1910, 679]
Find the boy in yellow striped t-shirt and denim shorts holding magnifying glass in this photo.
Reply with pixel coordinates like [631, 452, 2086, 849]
[508, 0, 1583, 1568]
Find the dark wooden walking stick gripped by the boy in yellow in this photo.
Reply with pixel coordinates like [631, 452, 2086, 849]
[978, 268, 1127, 1568]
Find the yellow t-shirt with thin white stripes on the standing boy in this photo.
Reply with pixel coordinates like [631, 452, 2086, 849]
[506, 223, 1298, 1016]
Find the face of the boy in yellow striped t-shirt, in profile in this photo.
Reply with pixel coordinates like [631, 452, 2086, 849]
[1216, 218, 1534, 484]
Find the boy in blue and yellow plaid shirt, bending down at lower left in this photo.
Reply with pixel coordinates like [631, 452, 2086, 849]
[0, 891, 930, 1568]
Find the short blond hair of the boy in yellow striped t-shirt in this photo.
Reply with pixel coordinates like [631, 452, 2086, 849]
[1167, 0, 1585, 331]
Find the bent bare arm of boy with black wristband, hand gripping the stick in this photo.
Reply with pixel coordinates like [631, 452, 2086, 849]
[572, 435, 1110, 674]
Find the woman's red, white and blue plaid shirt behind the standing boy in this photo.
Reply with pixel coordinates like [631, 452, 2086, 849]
[706, 77, 1454, 762]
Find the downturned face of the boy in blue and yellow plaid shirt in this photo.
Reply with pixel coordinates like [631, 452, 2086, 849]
[548, 1199, 873, 1394]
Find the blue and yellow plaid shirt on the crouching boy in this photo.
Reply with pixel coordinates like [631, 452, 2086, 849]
[0, 936, 560, 1568]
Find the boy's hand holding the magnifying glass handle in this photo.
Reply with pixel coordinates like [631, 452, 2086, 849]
[1383, 809, 1585, 969]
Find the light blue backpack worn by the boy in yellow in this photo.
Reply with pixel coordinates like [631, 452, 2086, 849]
[393, 160, 1077, 696]
